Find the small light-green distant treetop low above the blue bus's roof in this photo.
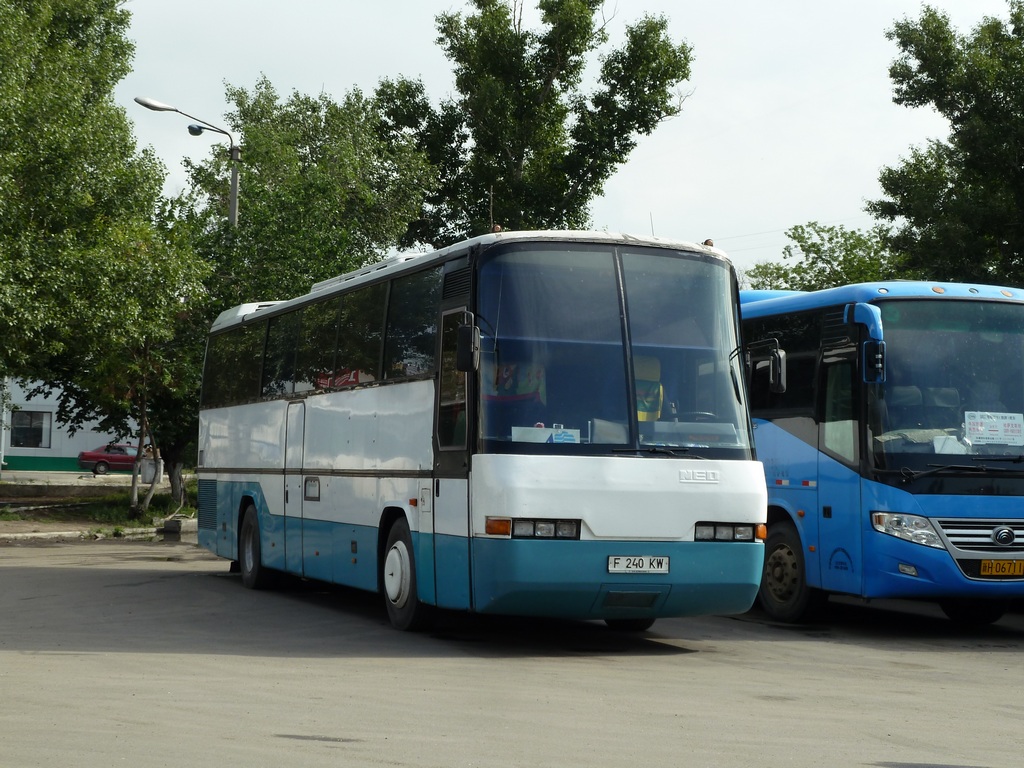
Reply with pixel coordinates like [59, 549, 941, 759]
[745, 221, 912, 291]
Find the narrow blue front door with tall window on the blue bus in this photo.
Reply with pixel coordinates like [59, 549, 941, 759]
[817, 349, 863, 595]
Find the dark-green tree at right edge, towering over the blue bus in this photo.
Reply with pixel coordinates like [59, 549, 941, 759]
[867, 0, 1024, 285]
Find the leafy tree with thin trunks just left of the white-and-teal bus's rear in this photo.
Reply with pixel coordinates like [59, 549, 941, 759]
[31, 210, 209, 514]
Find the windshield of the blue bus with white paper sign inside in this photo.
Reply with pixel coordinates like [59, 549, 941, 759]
[869, 300, 1024, 472]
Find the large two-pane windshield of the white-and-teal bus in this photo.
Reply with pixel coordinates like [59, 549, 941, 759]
[477, 243, 751, 460]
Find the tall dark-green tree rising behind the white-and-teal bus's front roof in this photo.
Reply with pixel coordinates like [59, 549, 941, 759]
[376, 0, 690, 246]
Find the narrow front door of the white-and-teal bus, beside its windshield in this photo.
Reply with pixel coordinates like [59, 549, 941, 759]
[430, 306, 473, 609]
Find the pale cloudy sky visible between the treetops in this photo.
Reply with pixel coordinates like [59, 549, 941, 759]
[115, 0, 1008, 269]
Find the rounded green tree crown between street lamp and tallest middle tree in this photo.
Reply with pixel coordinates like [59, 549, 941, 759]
[181, 78, 433, 309]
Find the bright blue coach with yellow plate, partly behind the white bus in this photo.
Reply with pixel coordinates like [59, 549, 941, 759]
[741, 282, 1024, 624]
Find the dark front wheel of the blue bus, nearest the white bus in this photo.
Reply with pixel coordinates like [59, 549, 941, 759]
[758, 521, 827, 622]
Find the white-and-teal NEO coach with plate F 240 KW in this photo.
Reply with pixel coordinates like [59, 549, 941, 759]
[198, 232, 766, 630]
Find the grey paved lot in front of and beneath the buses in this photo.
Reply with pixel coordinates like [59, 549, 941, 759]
[0, 542, 1024, 768]
